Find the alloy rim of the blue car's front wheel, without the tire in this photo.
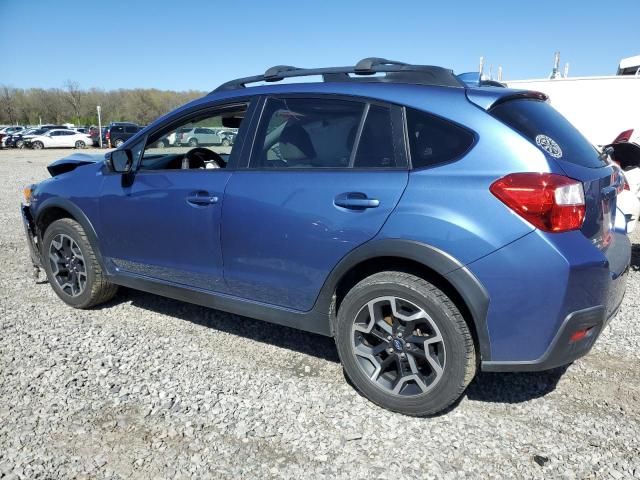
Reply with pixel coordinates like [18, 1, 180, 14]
[49, 233, 87, 297]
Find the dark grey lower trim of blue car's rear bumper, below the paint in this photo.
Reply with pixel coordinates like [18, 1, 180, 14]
[481, 305, 619, 372]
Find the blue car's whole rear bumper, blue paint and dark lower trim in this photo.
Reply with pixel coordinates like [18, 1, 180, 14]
[467, 227, 631, 371]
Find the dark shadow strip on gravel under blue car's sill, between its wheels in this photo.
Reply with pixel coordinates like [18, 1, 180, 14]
[101, 287, 340, 363]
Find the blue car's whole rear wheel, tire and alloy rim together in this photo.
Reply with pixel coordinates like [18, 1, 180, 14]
[336, 272, 476, 416]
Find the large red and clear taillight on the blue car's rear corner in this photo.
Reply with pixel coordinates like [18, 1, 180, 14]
[490, 173, 585, 232]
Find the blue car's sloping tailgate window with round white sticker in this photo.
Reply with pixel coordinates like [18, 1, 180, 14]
[491, 99, 605, 168]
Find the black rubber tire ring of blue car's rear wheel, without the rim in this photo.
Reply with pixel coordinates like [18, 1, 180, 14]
[336, 281, 467, 415]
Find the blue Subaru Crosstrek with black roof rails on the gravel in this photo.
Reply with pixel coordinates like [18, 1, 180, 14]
[22, 58, 630, 415]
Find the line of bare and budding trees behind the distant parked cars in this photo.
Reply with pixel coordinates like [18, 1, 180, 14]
[0, 81, 204, 125]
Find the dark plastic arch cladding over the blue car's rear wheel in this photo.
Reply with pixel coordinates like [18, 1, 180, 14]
[316, 239, 491, 360]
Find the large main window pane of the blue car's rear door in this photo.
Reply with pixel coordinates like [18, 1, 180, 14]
[250, 98, 365, 168]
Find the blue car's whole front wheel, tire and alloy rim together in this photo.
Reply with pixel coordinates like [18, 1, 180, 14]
[42, 218, 118, 309]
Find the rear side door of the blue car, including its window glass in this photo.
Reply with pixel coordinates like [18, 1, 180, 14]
[222, 97, 408, 311]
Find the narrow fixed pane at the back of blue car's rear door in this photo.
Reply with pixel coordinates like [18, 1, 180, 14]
[353, 105, 401, 168]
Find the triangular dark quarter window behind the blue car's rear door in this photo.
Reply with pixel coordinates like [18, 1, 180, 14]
[407, 108, 474, 168]
